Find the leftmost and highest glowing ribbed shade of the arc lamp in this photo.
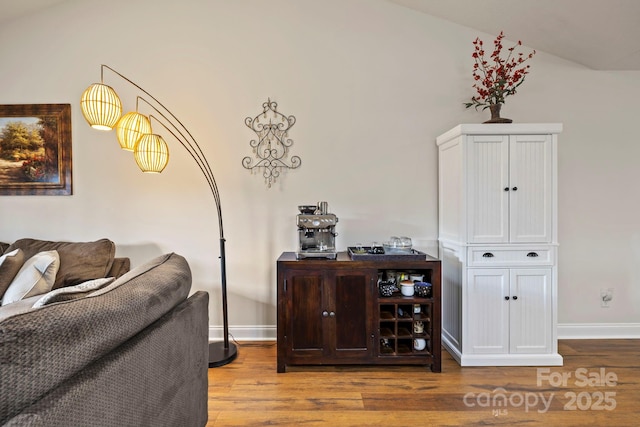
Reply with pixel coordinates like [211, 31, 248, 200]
[80, 83, 122, 130]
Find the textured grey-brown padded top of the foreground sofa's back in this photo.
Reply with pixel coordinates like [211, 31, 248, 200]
[0, 253, 191, 425]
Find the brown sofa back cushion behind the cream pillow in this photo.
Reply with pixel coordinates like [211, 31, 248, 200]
[7, 239, 116, 289]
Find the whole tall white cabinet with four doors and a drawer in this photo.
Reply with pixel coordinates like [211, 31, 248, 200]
[436, 124, 562, 366]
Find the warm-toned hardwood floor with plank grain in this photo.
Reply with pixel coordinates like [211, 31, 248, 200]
[207, 340, 640, 427]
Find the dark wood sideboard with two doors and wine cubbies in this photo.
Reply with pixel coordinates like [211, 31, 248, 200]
[277, 252, 441, 372]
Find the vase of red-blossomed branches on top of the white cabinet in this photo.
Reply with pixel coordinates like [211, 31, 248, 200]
[464, 31, 536, 123]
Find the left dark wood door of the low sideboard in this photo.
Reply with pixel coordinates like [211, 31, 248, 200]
[285, 270, 326, 358]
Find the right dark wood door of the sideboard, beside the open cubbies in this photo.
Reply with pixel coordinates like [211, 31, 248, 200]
[328, 271, 377, 358]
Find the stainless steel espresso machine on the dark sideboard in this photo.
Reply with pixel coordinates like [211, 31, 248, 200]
[296, 202, 338, 259]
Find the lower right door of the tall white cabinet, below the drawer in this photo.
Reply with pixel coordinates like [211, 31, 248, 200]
[509, 268, 553, 354]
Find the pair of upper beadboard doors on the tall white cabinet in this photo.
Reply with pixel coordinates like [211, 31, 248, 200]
[467, 134, 552, 243]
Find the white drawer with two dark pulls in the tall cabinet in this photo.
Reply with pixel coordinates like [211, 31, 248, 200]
[468, 246, 554, 267]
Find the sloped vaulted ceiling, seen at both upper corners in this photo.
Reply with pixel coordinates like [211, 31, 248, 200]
[5, 0, 640, 70]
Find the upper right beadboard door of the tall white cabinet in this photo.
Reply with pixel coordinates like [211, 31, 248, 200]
[508, 135, 553, 243]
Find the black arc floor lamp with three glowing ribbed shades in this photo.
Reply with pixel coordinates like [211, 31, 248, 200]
[80, 64, 238, 368]
